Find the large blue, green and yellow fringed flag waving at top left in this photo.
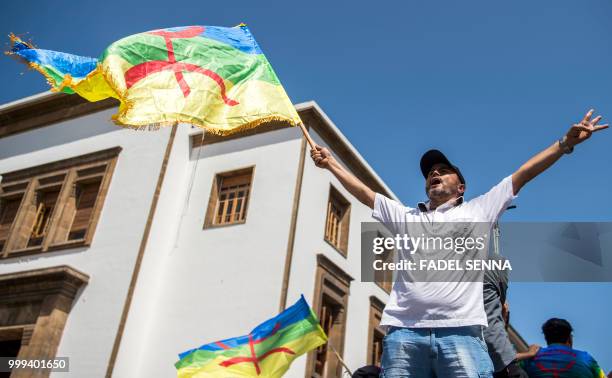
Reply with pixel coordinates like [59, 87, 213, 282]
[8, 24, 301, 135]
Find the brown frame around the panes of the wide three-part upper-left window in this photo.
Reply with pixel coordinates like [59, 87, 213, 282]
[0, 147, 121, 259]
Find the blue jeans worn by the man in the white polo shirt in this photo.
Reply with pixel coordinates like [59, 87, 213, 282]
[381, 326, 493, 378]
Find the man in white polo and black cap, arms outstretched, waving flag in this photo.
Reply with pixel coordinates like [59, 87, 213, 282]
[311, 110, 608, 378]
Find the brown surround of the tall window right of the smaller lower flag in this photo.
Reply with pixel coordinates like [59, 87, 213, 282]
[306, 254, 353, 378]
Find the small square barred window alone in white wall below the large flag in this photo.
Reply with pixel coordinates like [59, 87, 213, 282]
[204, 167, 253, 228]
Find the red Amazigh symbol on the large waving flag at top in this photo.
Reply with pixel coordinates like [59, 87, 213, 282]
[125, 26, 238, 106]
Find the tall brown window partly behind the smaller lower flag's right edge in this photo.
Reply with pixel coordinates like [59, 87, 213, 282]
[306, 254, 352, 378]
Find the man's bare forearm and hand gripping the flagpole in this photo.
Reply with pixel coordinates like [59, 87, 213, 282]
[310, 146, 376, 209]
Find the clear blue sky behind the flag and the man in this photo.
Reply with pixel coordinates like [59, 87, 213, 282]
[0, 0, 612, 372]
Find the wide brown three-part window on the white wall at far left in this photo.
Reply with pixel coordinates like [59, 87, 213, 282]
[0, 148, 121, 258]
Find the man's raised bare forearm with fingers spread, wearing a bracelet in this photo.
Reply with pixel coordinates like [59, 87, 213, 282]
[512, 109, 608, 195]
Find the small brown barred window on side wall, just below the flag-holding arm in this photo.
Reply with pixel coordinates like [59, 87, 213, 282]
[325, 186, 351, 256]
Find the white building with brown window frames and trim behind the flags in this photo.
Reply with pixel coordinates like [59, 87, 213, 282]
[0, 94, 394, 377]
